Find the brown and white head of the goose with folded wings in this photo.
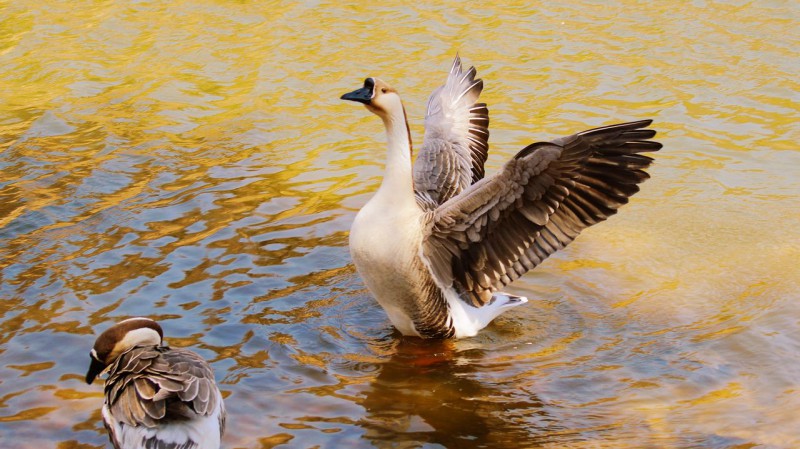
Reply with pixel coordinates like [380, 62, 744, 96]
[86, 318, 164, 384]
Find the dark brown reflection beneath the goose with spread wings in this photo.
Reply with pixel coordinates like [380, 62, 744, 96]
[359, 337, 552, 448]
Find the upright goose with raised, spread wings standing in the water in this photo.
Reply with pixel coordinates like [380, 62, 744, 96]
[341, 55, 661, 338]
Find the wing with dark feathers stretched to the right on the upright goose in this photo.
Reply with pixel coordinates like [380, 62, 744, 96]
[423, 120, 661, 307]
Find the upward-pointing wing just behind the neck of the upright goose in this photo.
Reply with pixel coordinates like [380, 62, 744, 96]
[414, 56, 489, 205]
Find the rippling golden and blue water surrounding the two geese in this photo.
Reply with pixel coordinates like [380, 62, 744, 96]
[0, 1, 800, 449]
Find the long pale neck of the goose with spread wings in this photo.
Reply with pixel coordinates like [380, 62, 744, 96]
[375, 97, 416, 207]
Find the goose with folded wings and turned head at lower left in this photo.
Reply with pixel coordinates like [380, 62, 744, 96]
[86, 317, 225, 449]
